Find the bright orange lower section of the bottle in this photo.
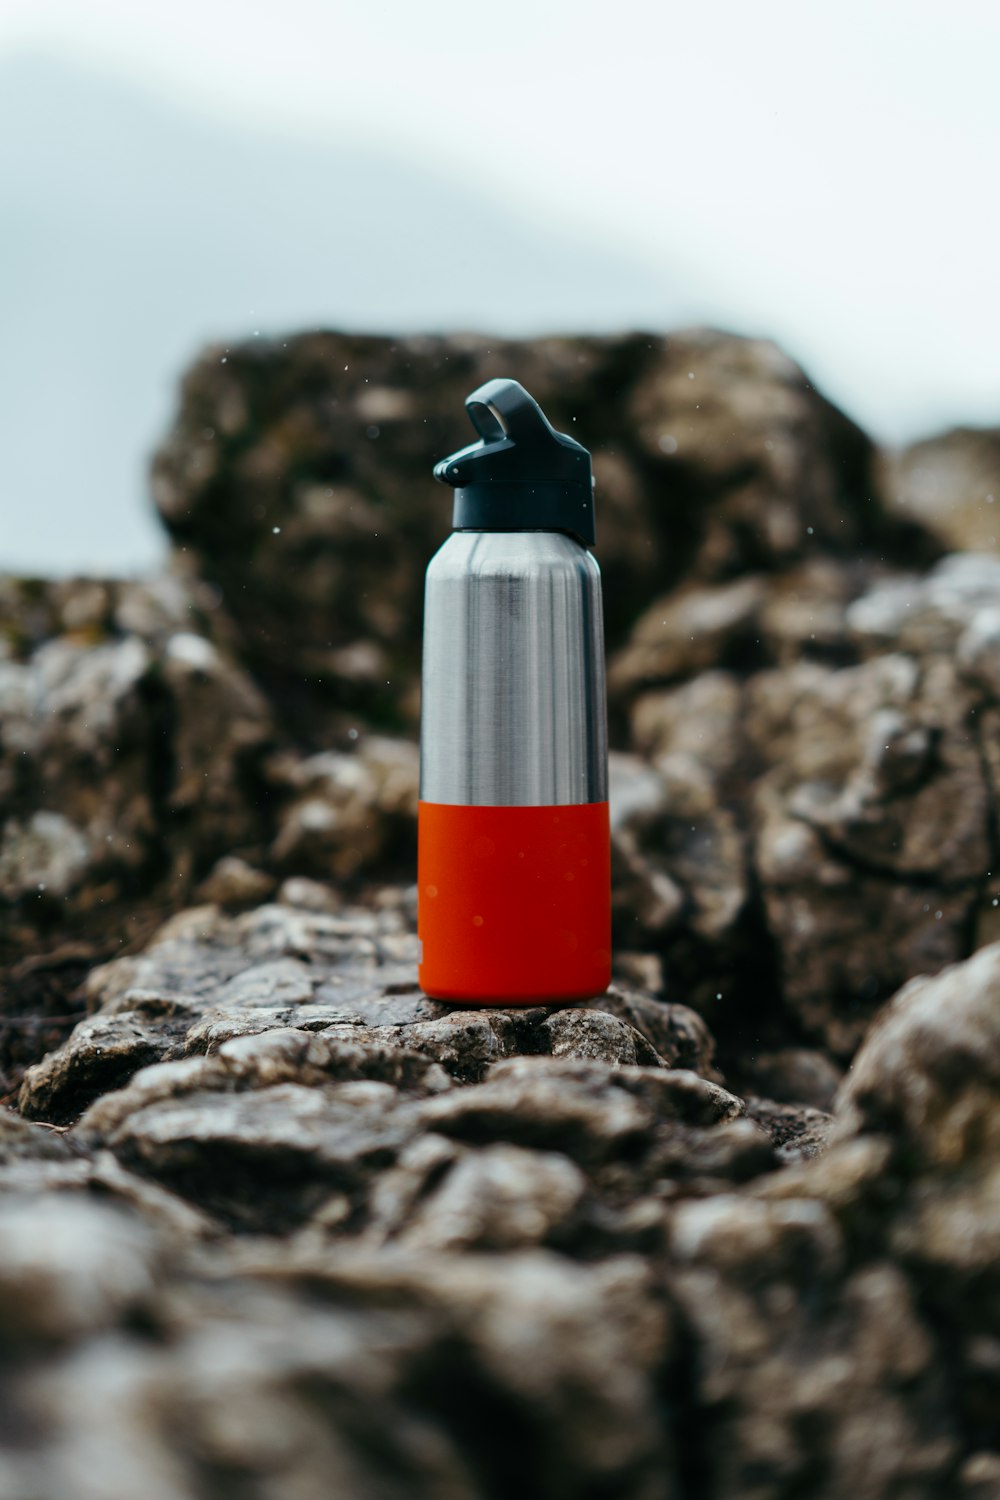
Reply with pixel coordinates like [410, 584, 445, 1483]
[417, 803, 612, 1005]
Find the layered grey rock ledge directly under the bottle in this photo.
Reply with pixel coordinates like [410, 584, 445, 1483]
[11, 906, 774, 1266]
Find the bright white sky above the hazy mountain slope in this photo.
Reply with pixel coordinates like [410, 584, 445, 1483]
[0, 0, 1000, 440]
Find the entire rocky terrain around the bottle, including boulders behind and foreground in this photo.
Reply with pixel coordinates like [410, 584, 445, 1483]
[0, 333, 1000, 1500]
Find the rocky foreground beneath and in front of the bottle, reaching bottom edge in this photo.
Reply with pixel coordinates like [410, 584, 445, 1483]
[0, 882, 1000, 1500]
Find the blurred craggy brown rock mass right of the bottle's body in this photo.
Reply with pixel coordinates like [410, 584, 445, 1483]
[613, 554, 1000, 1068]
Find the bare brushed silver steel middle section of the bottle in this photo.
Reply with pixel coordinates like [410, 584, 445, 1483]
[420, 531, 607, 807]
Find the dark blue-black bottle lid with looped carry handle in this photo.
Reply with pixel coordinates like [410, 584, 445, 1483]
[435, 380, 595, 548]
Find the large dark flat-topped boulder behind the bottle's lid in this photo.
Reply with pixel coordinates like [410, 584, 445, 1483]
[154, 330, 930, 744]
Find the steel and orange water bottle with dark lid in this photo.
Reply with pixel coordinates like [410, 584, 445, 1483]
[417, 380, 612, 1005]
